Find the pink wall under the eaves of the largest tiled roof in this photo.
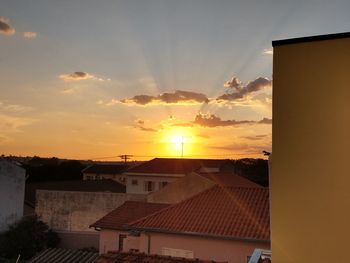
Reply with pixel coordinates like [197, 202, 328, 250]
[140, 233, 270, 263]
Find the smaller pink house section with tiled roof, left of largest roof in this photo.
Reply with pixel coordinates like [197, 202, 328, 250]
[90, 201, 168, 254]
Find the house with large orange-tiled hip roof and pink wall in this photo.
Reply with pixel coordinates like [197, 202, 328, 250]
[128, 186, 270, 263]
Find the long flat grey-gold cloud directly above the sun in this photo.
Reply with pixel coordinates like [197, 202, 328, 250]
[120, 90, 209, 106]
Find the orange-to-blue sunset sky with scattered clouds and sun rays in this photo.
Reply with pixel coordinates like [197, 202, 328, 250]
[0, 0, 350, 160]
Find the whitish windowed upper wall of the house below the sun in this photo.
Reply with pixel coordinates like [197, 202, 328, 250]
[126, 174, 183, 194]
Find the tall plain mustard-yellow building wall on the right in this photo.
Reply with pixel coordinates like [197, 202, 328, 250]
[271, 34, 350, 263]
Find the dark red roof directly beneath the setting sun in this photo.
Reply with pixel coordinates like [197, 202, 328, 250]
[127, 158, 229, 174]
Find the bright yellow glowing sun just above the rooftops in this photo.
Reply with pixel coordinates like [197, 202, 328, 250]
[161, 128, 196, 157]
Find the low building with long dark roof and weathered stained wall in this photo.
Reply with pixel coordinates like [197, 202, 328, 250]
[33, 179, 146, 249]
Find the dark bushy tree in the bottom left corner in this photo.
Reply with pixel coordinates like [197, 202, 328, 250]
[0, 216, 59, 259]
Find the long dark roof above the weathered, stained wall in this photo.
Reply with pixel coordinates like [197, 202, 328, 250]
[25, 179, 126, 204]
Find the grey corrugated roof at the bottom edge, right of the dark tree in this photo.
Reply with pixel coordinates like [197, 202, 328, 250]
[29, 248, 99, 263]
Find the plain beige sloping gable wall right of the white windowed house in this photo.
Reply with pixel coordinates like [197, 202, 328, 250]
[147, 173, 215, 204]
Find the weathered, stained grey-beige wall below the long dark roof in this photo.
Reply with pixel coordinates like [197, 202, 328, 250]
[35, 190, 146, 231]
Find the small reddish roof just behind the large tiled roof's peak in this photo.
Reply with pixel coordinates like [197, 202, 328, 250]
[198, 172, 262, 187]
